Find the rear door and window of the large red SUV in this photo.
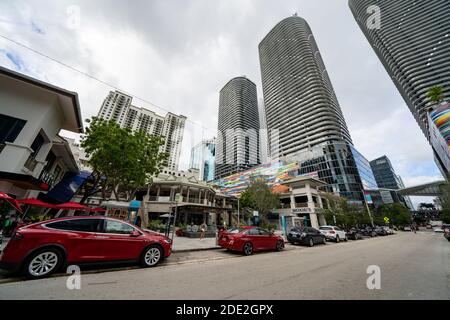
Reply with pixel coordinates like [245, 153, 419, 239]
[44, 218, 104, 262]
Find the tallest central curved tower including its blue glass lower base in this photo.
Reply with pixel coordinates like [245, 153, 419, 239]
[259, 15, 364, 203]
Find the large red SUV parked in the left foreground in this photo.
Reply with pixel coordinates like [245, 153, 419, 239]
[0, 216, 172, 278]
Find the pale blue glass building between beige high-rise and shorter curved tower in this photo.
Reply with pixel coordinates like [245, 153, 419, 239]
[189, 138, 216, 181]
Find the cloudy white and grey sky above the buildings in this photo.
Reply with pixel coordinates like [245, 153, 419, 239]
[0, 0, 442, 209]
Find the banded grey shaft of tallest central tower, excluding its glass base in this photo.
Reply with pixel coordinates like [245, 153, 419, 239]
[259, 16, 352, 157]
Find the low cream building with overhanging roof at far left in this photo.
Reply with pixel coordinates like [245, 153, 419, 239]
[0, 67, 83, 198]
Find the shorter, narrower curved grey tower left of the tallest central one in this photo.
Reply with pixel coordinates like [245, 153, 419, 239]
[214, 77, 260, 179]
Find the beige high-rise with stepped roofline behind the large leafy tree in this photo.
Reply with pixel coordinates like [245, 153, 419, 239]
[98, 91, 186, 171]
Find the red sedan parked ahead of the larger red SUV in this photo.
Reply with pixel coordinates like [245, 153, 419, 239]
[219, 227, 284, 256]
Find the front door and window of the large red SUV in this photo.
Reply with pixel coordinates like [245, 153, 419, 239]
[97, 219, 145, 260]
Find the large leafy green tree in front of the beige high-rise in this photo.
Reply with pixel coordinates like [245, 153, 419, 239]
[81, 117, 168, 201]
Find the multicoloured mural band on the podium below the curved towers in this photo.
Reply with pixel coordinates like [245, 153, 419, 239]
[214, 162, 299, 196]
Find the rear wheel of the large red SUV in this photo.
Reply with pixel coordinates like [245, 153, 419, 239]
[24, 248, 63, 279]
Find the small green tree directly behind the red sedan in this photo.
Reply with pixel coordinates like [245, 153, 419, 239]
[239, 179, 280, 221]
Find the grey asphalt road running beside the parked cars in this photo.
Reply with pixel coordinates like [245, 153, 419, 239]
[0, 232, 450, 300]
